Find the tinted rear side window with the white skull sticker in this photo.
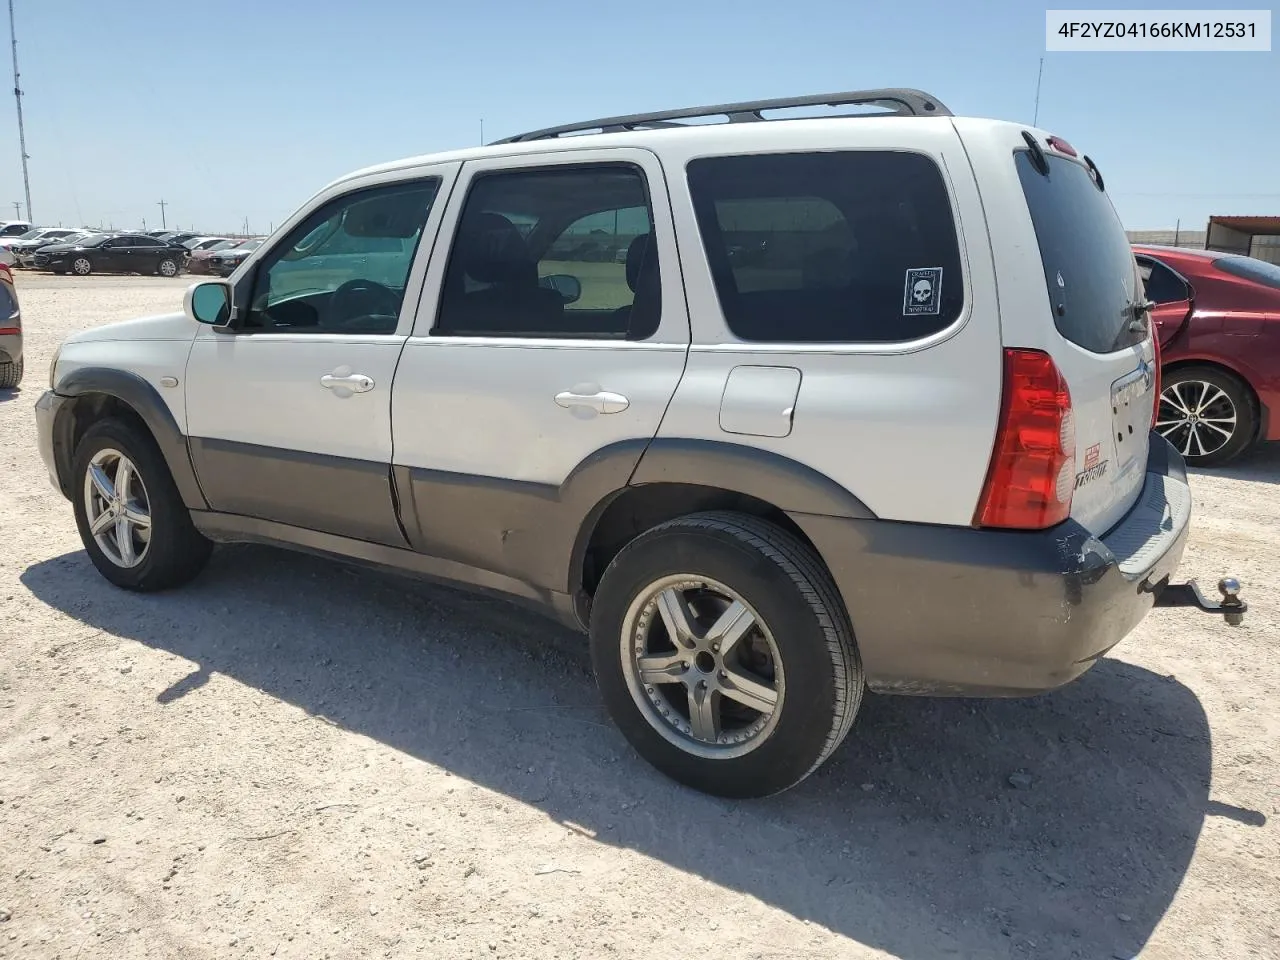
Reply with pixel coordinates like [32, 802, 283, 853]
[687, 151, 964, 343]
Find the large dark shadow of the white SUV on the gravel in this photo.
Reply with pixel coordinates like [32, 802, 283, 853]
[22, 547, 1218, 960]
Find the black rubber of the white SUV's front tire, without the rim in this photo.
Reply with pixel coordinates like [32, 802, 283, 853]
[72, 420, 209, 590]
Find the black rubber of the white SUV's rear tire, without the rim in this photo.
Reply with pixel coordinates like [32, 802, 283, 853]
[591, 526, 860, 797]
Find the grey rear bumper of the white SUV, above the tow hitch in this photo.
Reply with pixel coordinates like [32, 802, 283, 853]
[794, 435, 1190, 696]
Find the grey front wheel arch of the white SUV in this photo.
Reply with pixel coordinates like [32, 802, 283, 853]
[52, 367, 209, 509]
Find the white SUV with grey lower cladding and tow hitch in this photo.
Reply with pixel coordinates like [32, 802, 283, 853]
[37, 90, 1244, 796]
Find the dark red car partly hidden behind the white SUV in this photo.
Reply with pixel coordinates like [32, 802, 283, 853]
[1133, 244, 1280, 466]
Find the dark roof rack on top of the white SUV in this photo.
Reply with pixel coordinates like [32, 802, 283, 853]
[494, 87, 952, 143]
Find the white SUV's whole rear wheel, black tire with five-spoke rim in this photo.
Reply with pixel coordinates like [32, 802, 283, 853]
[590, 512, 864, 797]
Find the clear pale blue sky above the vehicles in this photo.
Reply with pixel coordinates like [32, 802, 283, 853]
[0, 0, 1280, 232]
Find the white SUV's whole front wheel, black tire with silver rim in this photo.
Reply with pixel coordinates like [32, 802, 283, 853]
[72, 420, 212, 591]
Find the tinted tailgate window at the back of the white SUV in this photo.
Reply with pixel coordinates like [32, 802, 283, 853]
[1015, 150, 1147, 353]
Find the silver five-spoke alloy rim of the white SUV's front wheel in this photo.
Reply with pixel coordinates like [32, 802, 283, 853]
[84, 448, 151, 568]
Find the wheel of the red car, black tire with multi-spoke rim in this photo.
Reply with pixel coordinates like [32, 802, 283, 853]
[1156, 366, 1258, 467]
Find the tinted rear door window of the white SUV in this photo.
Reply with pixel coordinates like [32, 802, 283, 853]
[433, 164, 662, 339]
